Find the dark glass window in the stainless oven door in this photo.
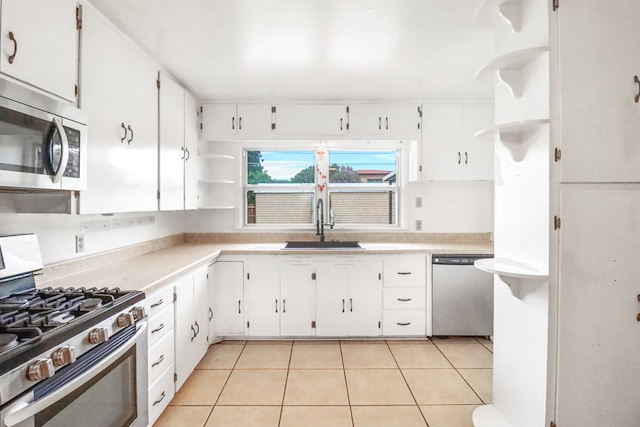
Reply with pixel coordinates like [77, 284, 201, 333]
[35, 346, 137, 427]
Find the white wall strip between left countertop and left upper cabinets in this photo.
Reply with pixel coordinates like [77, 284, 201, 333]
[0, 210, 184, 264]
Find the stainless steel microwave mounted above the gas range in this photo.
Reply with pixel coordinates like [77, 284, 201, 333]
[0, 78, 87, 190]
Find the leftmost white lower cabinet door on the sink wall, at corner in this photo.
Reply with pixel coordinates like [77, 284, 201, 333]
[211, 261, 244, 336]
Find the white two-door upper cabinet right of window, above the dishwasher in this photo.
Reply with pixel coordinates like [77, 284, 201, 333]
[422, 104, 494, 180]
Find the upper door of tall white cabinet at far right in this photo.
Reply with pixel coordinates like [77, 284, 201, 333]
[557, 0, 640, 182]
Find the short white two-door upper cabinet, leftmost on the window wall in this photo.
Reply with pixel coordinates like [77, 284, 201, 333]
[201, 104, 272, 141]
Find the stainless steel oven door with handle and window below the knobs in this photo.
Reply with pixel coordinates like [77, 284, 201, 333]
[0, 319, 148, 427]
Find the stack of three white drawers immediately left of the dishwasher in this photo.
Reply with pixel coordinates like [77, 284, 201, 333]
[382, 256, 427, 336]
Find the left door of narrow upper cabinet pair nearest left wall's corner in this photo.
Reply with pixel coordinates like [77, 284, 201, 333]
[159, 73, 186, 211]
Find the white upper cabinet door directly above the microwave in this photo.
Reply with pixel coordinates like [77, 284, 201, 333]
[0, 0, 78, 103]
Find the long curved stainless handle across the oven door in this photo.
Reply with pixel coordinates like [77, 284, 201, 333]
[4, 322, 147, 427]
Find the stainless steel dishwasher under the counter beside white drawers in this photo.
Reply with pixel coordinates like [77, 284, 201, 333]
[432, 255, 493, 336]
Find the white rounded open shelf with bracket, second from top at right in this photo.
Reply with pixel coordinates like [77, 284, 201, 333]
[476, 46, 549, 98]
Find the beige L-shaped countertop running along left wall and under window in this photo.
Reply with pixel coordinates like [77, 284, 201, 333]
[37, 239, 493, 292]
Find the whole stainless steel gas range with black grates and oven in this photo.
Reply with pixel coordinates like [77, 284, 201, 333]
[0, 234, 148, 427]
